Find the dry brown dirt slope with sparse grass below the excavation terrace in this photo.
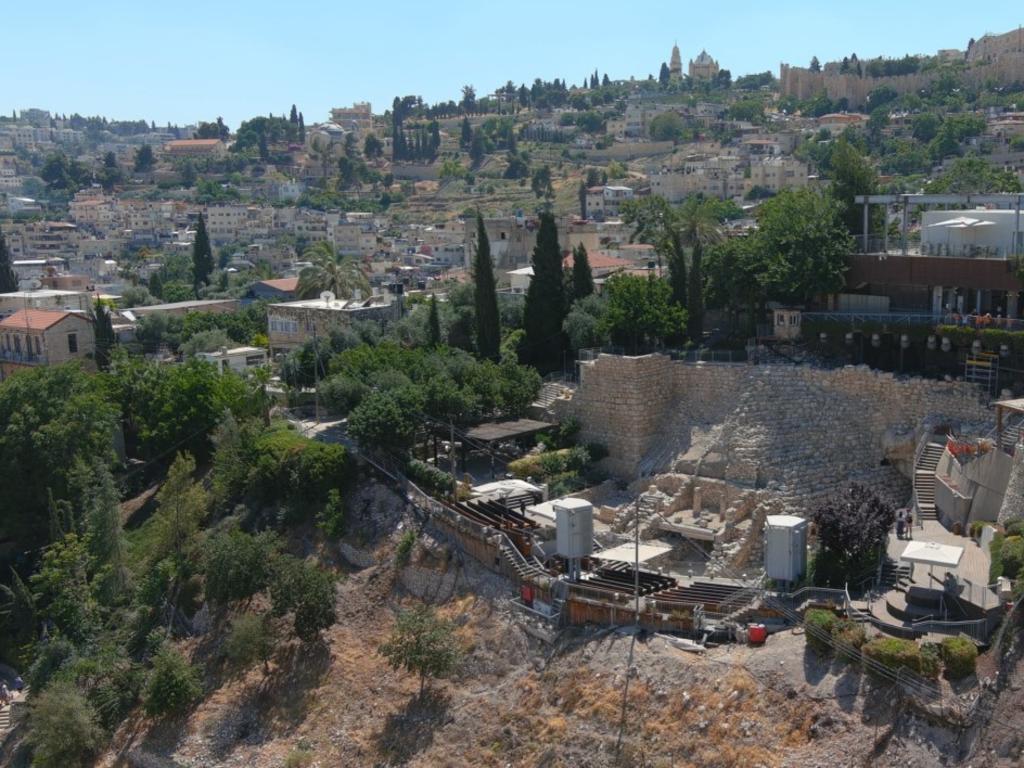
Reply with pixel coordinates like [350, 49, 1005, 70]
[92, 481, 1024, 768]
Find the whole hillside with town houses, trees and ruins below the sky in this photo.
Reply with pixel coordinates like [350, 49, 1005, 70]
[0, 15, 1024, 768]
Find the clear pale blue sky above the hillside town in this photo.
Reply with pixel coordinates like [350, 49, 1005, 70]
[0, 0, 1024, 128]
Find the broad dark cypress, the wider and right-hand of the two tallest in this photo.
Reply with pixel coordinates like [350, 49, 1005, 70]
[523, 212, 566, 372]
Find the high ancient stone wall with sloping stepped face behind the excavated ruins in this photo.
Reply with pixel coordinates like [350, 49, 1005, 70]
[561, 355, 990, 509]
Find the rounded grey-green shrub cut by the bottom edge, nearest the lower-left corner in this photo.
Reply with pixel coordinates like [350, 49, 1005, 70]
[29, 682, 102, 768]
